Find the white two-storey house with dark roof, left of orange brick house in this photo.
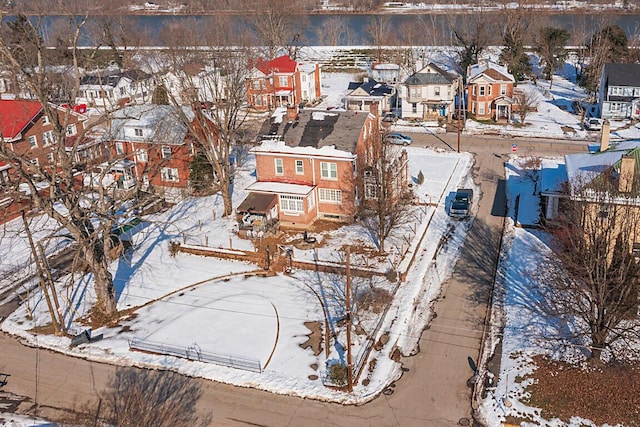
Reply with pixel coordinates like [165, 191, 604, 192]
[401, 63, 461, 120]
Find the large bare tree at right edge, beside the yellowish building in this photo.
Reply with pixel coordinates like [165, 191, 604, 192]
[552, 172, 640, 360]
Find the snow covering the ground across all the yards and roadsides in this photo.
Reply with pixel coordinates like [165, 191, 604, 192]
[5, 54, 640, 425]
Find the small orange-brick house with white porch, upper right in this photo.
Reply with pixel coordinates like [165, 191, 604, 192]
[467, 59, 515, 122]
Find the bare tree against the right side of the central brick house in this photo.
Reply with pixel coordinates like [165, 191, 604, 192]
[358, 132, 411, 253]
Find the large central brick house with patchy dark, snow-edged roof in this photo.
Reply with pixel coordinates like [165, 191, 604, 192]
[236, 108, 379, 229]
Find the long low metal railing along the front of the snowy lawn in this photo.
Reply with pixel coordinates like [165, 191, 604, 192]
[129, 337, 262, 373]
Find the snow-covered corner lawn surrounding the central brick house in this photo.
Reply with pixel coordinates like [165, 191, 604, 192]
[0, 147, 472, 402]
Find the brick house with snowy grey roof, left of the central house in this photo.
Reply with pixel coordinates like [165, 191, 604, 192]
[103, 105, 205, 203]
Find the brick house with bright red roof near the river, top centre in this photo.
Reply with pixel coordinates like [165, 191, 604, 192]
[246, 55, 321, 110]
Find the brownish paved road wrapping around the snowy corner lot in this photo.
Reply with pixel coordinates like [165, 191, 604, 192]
[0, 134, 586, 427]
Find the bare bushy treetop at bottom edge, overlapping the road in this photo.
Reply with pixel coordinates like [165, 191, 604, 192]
[99, 368, 210, 427]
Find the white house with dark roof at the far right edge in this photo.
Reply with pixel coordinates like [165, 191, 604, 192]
[598, 64, 640, 120]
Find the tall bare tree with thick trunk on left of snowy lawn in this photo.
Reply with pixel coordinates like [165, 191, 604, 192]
[0, 10, 162, 324]
